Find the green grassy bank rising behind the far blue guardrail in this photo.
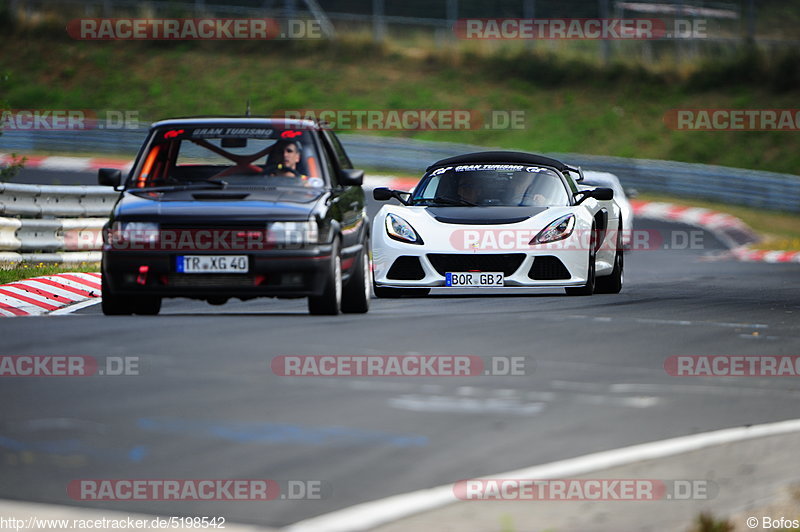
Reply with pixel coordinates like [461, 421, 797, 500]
[0, 28, 800, 173]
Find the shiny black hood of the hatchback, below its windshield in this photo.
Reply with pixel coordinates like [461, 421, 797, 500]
[114, 188, 326, 223]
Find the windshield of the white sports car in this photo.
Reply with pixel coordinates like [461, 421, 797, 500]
[412, 164, 569, 207]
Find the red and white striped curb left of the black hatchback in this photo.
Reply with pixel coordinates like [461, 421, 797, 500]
[0, 273, 101, 317]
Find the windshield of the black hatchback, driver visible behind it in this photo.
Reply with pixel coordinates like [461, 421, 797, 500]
[129, 126, 325, 188]
